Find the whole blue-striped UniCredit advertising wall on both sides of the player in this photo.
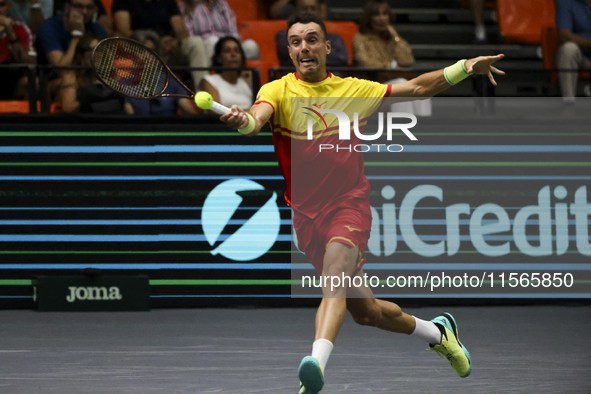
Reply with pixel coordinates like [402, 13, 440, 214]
[0, 117, 591, 308]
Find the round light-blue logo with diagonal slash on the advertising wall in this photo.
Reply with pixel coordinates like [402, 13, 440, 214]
[201, 179, 281, 261]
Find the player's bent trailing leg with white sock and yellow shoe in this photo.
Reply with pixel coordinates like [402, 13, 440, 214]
[347, 271, 472, 378]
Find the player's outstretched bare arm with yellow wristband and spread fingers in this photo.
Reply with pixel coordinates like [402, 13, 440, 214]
[390, 55, 505, 98]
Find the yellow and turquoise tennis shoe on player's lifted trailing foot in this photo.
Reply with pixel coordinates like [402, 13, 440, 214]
[427, 313, 472, 378]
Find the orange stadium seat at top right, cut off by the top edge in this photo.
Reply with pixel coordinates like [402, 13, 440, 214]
[497, 0, 555, 44]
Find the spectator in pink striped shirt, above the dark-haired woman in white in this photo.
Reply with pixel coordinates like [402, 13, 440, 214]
[179, 0, 259, 59]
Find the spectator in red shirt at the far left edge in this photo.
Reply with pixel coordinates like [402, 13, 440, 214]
[0, 0, 36, 99]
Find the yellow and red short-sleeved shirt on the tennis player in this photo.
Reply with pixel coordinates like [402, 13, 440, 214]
[255, 73, 391, 219]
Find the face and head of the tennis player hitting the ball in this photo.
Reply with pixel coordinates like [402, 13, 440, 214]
[287, 23, 330, 82]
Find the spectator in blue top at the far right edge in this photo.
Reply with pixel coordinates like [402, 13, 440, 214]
[556, 0, 591, 103]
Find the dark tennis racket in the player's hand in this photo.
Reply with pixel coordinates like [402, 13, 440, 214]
[92, 37, 230, 115]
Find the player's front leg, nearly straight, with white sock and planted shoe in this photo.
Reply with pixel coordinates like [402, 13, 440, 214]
[298, 242, 359, 394]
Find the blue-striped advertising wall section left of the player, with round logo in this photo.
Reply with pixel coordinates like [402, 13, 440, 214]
[0, 118, 291, 307]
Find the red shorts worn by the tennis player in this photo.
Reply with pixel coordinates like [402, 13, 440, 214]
[293, 198, 371, 276]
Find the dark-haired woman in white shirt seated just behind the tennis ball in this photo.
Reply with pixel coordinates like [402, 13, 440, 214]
[200, 36, 253, 110]
